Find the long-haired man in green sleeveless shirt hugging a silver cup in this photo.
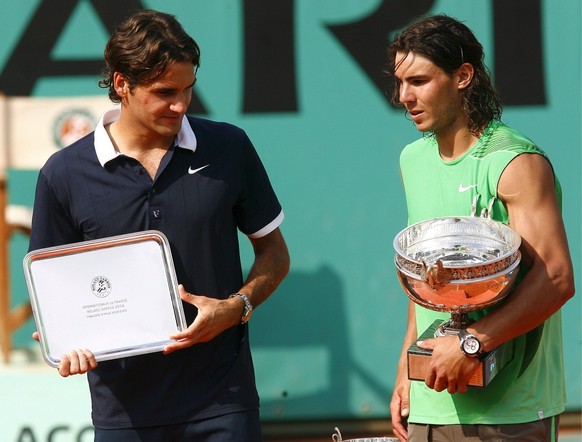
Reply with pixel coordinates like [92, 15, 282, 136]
[388, 15, 574, 442]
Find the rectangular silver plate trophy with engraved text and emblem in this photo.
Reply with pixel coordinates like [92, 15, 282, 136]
[23, 230, 187, 367]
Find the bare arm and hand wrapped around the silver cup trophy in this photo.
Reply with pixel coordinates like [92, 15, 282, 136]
[422, 154, 574, 393]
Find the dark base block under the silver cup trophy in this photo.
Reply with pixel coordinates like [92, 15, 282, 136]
[408, 319, 513, 387]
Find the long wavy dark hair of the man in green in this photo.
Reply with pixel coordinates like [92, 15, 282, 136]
[387, 14, 503, 134]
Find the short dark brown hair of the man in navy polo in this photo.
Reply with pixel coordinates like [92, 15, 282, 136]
[99, 9, 200, 103]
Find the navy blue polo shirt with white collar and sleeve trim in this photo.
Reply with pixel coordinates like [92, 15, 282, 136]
[29, 111, 283, 429]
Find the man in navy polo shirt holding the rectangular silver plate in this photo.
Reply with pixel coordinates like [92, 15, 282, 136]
[30, 10, 289, 442]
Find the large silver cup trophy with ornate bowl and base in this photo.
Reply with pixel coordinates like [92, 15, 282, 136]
[394, 216, 521, 386]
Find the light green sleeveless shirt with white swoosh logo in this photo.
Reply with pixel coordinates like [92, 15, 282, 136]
[400, 120, 566, 425]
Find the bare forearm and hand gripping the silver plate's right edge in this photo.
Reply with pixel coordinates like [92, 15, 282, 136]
[164, 228, 290, 354]
